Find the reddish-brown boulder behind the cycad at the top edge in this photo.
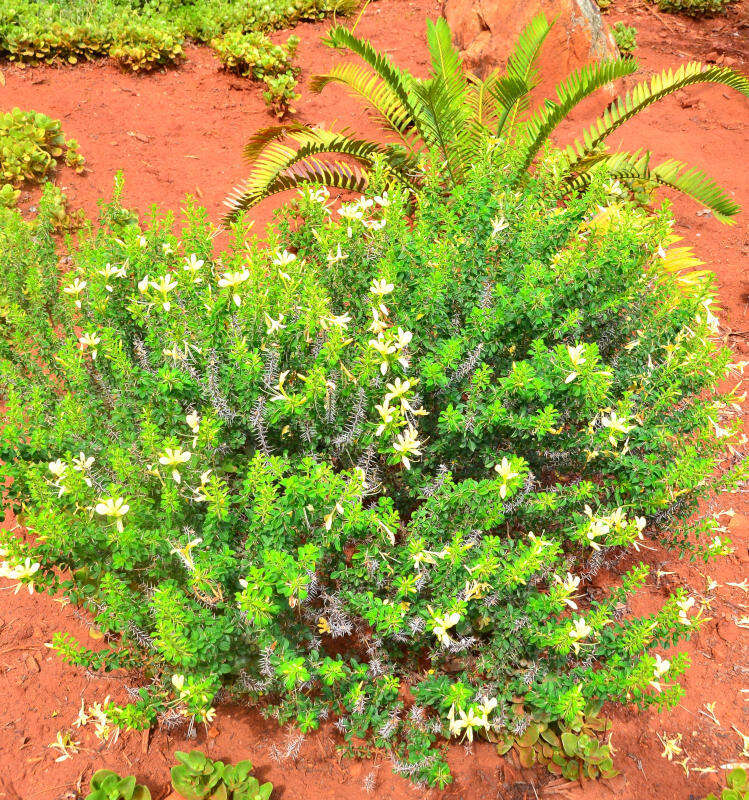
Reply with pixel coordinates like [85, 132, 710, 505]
[442, 0, 618, 89]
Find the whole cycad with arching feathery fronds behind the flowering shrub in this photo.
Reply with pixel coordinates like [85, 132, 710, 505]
[225, 14, 749, 222]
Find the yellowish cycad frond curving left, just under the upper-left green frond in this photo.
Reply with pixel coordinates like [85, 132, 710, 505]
[310, 63, 413, 144]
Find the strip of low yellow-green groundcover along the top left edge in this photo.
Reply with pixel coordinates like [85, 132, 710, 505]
[0, 0, 357, 115]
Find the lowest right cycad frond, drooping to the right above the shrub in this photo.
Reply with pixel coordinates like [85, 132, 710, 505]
[567, 150, 741, 223]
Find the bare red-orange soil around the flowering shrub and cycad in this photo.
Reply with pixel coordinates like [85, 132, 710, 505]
[0, 0, 749, 800]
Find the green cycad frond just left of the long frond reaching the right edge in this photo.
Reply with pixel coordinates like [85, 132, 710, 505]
[519, 58, 638, 172]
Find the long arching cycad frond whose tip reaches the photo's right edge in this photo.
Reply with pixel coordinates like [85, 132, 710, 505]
[567, 61, 749, 165]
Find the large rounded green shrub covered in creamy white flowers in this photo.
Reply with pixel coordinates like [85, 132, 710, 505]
[0, 150, 746, 785]
